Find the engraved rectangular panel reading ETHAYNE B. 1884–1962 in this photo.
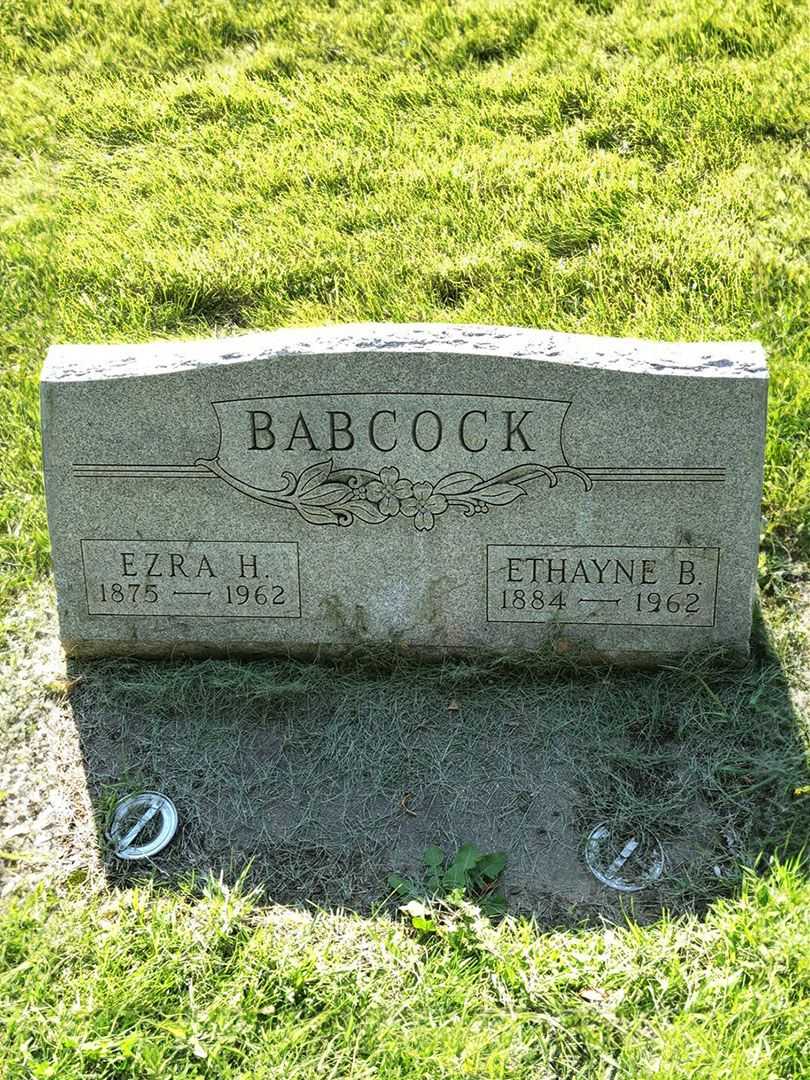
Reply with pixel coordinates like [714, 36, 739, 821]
[487, 544, 719, 626]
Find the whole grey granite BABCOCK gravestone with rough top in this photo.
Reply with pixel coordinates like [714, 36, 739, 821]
[41, 324, 767, 662]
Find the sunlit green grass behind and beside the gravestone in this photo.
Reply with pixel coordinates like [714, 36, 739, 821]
[0, 0, 810, 617]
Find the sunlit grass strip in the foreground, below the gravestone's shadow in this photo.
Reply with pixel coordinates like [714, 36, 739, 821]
[0, 864, 810, 1080]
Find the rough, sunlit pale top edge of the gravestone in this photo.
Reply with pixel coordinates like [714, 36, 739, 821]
[41, 323, 768, 383]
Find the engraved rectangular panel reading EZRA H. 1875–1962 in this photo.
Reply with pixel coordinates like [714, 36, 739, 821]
[81, 539, 301, 619]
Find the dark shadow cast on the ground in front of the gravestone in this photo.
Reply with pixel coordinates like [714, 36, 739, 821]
[58, 609, 810, 926]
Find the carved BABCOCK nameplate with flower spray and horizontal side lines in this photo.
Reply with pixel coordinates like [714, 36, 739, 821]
[75, 392, 725, 531]
